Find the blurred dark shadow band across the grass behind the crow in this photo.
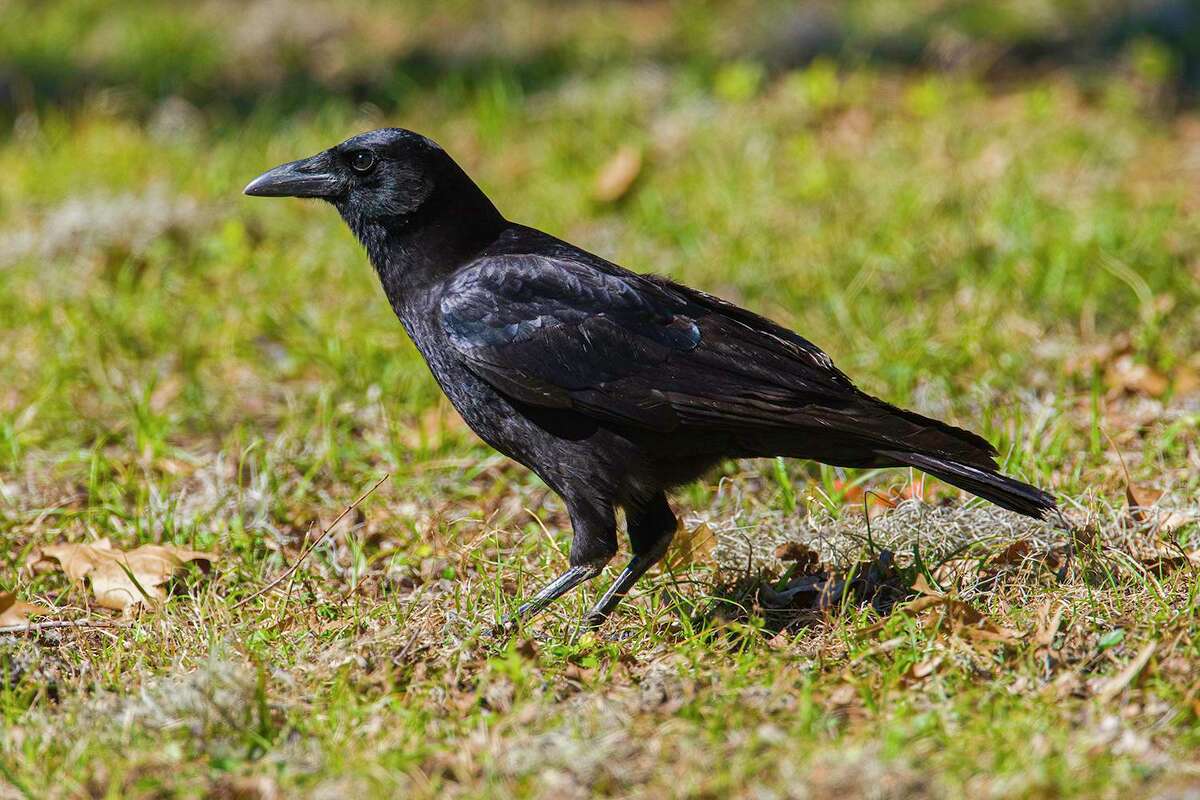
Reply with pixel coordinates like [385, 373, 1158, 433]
[7, 0, 1200, 125]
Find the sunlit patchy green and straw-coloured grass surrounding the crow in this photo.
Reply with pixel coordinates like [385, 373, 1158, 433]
[0, 2, 1200, 798]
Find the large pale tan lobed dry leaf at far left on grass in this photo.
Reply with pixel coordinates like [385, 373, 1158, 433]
[32, 539, 217, 610]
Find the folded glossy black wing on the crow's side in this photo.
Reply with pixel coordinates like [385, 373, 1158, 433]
[440, 255, 864, 431]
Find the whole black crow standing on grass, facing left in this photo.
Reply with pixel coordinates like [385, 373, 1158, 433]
[245, 128, 1057, 625]
